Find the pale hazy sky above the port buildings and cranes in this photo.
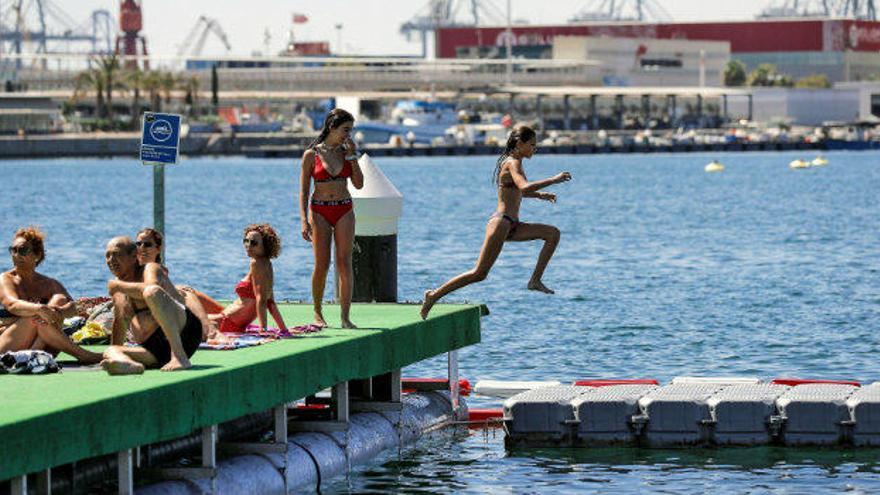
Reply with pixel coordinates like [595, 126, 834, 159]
[43, 0, 778, 56]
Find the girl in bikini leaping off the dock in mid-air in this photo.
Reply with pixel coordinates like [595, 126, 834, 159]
[421, 126, 571, 319]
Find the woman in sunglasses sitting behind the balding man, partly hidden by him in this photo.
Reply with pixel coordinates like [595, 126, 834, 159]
[129, 227, 227, 342]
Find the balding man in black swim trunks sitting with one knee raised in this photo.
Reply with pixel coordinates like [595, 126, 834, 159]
[102, 237, 202, 375]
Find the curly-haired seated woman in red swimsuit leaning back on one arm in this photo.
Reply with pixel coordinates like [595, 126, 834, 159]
[198, 223, 288, 333]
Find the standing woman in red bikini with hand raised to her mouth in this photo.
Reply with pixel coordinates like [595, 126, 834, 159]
[299, 108, 364, 328]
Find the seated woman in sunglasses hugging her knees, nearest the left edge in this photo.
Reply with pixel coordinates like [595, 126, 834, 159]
[0, 227, 101, 363]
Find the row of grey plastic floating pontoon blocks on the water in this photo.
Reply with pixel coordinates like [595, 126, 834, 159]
[503, 376, 880, 448]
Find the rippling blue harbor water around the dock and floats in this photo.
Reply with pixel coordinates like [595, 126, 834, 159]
[0, 152, 880, 493]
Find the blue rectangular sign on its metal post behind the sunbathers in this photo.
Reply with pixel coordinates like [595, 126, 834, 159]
[140, 112, 181, 255]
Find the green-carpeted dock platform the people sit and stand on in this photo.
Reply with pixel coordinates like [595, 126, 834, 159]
[0, 304, 487, 480]
